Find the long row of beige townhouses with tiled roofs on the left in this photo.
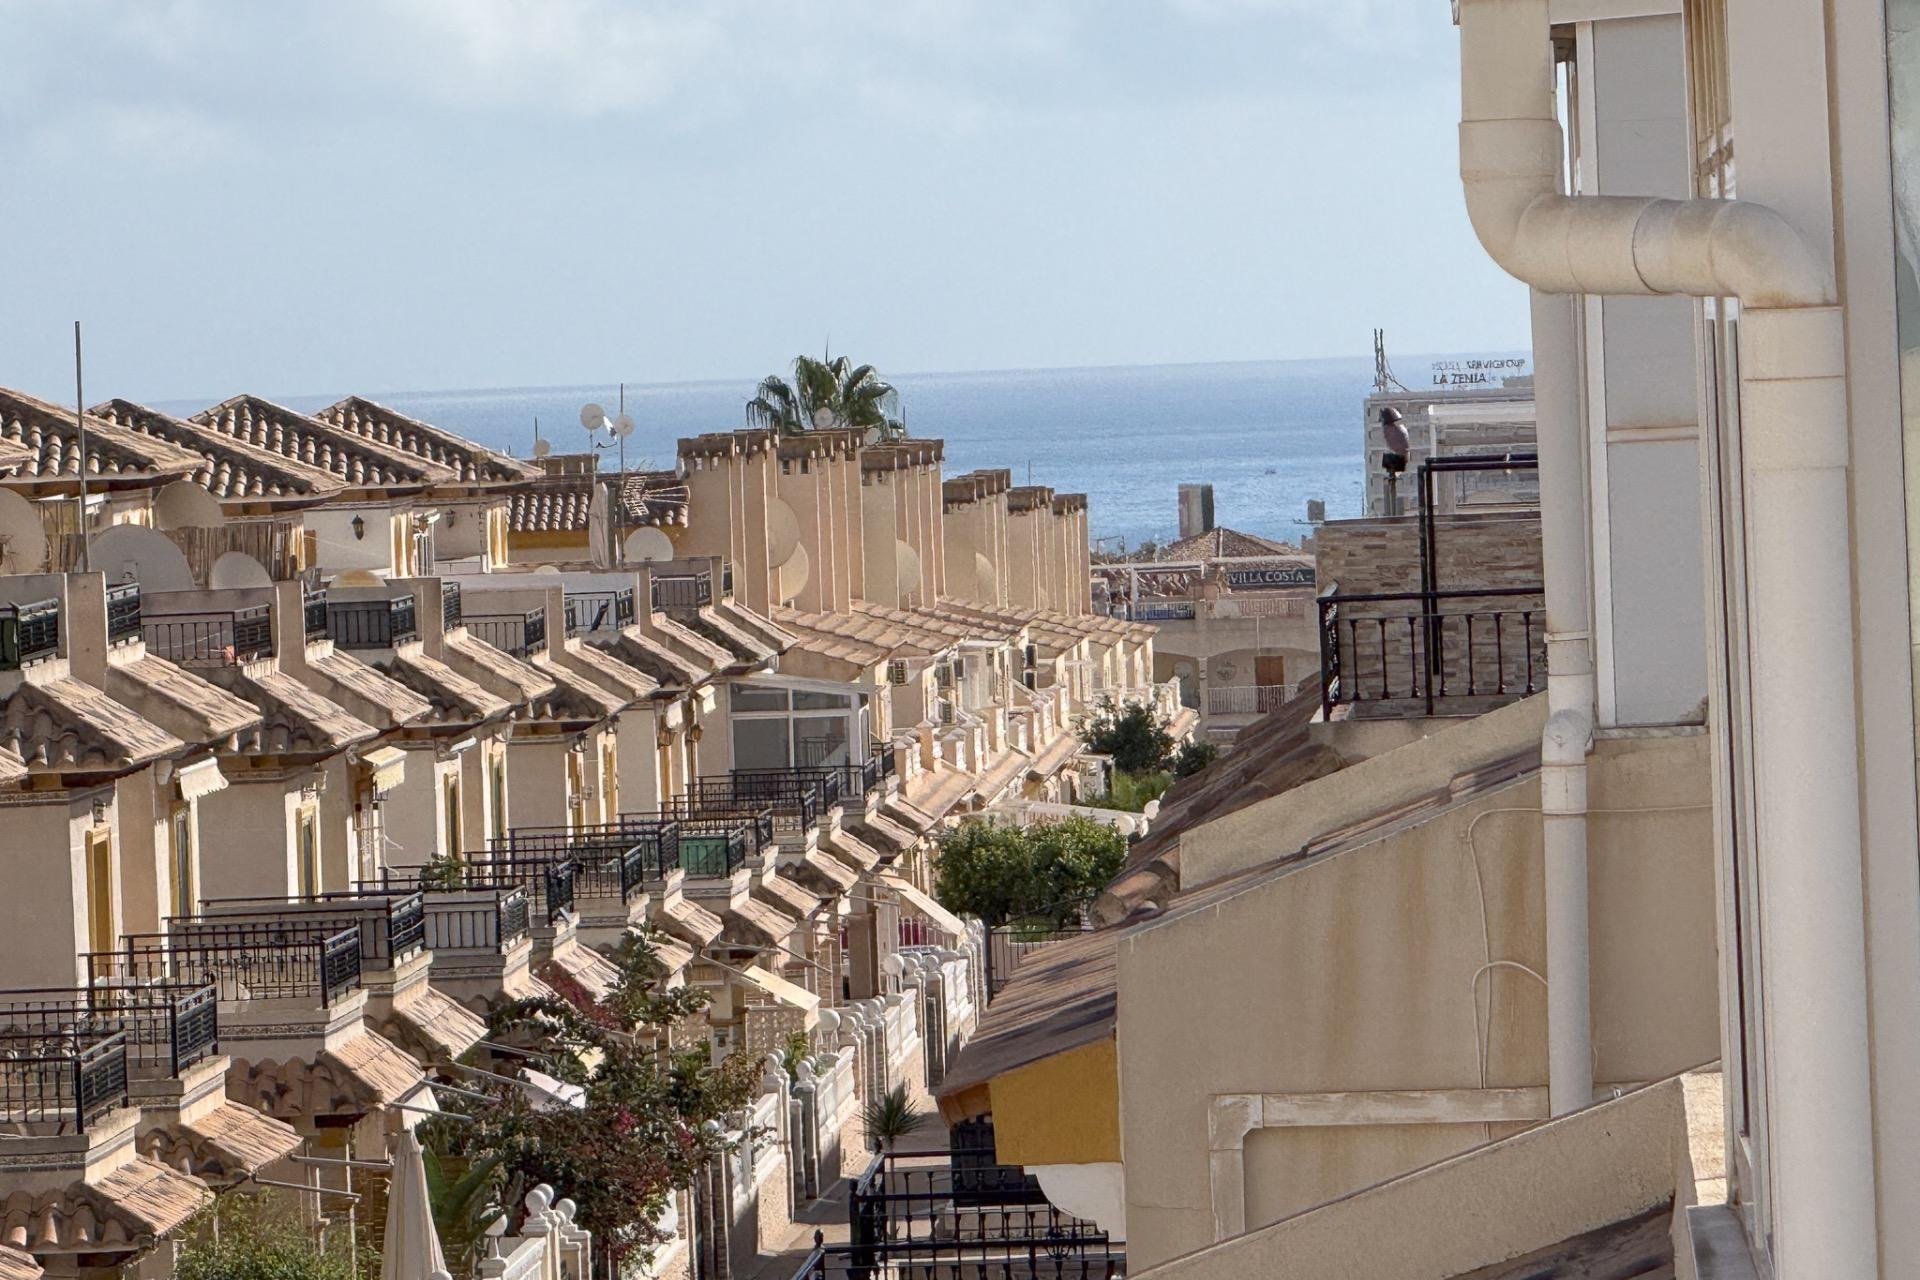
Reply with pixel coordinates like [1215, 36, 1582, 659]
[0, 391, 1185, 1278]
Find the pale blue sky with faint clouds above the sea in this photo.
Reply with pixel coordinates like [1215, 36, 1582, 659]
[0, 0, 1526, 401]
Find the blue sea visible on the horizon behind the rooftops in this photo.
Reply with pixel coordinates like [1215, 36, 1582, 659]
[243, 351, 1524, 551]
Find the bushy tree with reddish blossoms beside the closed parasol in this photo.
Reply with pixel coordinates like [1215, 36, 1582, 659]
[420, 935, 760, 1274]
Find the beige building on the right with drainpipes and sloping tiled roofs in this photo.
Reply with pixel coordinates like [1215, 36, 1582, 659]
[941, 0, 1920, 1280]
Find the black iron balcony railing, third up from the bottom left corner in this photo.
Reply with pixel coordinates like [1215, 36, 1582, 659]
[86, 921, 361, 1007]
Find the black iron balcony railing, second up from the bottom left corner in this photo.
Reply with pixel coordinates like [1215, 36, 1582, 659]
[0, 983, 221, 1079]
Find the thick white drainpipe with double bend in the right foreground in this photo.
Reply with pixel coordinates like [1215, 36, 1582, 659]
[1459, 0, 1878, 1280]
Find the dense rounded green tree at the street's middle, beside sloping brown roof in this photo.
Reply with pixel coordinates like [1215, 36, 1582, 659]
[933, 816, 1127, 927]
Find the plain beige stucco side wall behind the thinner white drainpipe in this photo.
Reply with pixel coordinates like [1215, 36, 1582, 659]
[1117, 735, 1718, 1265]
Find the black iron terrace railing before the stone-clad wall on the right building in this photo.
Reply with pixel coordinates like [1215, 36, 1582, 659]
[1319, 587, 1546, 716]
